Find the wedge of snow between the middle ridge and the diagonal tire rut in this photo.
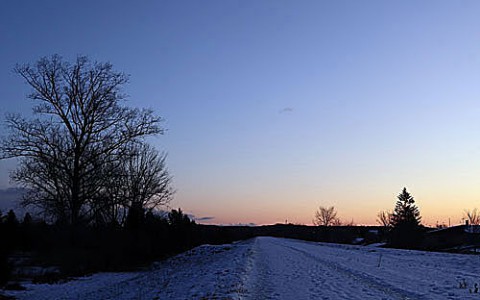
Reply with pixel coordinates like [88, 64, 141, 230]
[247, 237, 422, 300]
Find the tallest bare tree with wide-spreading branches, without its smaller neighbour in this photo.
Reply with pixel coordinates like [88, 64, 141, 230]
[0, 55, 163, 224]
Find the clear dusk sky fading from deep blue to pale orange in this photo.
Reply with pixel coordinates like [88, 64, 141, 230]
[0, 0, 480, 225]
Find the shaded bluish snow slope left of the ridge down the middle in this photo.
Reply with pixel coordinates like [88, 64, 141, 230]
[7, 242, 251, 300]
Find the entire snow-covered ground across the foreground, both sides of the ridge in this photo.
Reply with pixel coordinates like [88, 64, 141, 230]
[8, 237, 480, 300]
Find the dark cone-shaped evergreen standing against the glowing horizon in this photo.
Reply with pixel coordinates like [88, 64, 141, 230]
[390, 188, 422, 248]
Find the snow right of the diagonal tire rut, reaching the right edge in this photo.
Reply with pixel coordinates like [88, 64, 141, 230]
[291, 241, 480, 300]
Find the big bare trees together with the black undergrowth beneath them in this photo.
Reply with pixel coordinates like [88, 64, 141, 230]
[0, 55, 182, 288]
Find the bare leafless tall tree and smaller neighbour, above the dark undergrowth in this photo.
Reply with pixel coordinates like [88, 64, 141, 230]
[0, 55, 174, 226]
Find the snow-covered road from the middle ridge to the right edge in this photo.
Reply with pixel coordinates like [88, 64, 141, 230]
[247, 237, 480, 300]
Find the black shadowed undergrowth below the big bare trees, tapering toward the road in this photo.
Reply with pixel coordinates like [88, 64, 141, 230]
[0, 209, 251, 284]
